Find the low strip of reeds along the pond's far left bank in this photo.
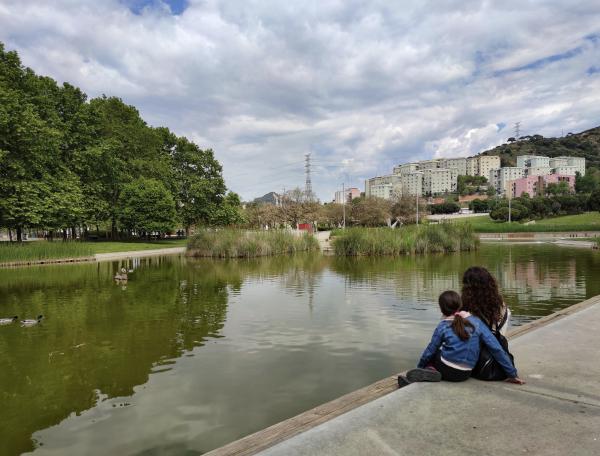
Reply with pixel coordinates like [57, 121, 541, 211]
[0, 239, 186, 263]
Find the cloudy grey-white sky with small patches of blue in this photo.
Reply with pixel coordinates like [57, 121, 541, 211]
[0, 0, 600, 200]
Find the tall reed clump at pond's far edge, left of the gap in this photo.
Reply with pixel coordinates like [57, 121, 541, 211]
[186, 230, 319, 258]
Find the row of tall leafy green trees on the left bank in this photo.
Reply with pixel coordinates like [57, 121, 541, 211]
[0, 43, 241, 240]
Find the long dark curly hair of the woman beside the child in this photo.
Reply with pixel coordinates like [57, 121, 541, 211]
[461, 266, 504, 327]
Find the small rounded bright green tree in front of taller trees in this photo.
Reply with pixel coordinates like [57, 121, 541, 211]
[118, 177, 176, 236]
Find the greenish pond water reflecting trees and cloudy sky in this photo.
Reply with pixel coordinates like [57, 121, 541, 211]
[0, 245, 600, 455]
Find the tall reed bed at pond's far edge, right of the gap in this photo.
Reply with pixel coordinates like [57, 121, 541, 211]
[333, 223, 479, 256]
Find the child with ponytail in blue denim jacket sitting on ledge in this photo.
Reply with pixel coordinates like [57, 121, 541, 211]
[398, 291, 525, 387]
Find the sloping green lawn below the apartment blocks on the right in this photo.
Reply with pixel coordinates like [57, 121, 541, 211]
[453, 212, 600, 233]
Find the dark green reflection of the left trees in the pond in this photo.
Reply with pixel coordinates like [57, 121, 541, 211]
[0, 258, 228, 454]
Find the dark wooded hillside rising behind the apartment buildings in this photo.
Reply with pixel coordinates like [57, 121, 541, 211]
[479, 127, 600, 168]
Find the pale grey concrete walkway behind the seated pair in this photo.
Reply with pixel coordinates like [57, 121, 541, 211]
[260, 298, 600, 456]
